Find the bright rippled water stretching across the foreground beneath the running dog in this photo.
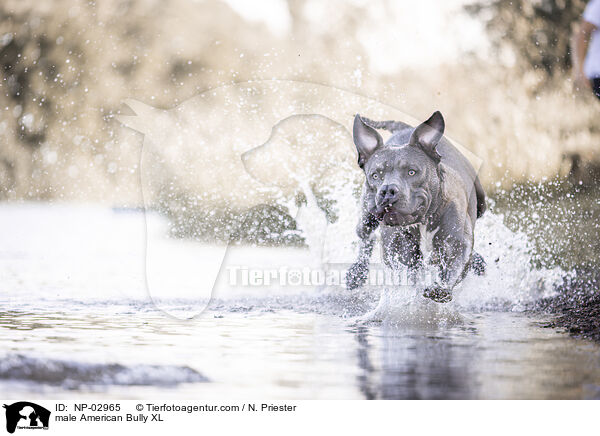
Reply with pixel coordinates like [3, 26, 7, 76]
[0, 204, 600, 400]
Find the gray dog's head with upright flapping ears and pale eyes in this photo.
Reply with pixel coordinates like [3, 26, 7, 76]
[353, 112, 444, 226]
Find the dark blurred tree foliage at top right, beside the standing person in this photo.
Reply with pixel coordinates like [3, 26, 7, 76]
[466, 0, 586, 76]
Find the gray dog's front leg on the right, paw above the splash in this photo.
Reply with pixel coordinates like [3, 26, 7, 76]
[423, 220, 473, 303]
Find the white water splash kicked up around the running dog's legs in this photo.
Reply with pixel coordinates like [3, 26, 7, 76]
[290, 177, 566, 325]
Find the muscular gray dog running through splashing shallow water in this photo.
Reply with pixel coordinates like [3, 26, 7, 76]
[346, 112, 485, 303]
